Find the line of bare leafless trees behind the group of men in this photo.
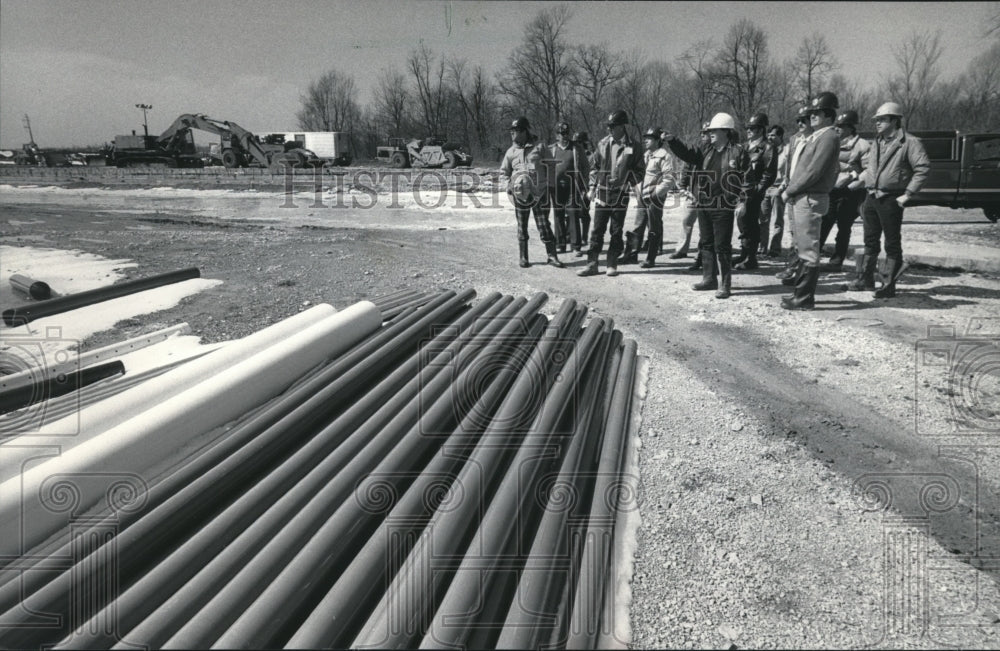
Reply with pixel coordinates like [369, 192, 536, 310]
[296, 5, 1000, 163]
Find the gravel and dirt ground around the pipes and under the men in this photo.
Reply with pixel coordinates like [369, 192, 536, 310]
[0, 176, 1000, 648]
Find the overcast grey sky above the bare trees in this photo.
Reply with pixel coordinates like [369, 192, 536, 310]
[0, 0, 998, 149]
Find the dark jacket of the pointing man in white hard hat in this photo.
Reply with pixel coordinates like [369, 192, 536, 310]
[667, 136, 750, 210]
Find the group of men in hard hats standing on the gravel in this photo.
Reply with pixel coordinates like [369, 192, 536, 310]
[501, 92, 930, 310]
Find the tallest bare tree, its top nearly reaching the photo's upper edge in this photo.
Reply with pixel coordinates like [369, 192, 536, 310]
[497, 5, 573, 138]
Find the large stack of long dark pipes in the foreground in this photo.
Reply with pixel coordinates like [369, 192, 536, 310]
[0, 290, 636, 648]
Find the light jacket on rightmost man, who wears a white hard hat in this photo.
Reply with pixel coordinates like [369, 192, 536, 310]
[861, 129, 931, 197]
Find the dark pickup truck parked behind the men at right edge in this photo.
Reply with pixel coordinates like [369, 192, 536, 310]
[861, 131, 1000, 223]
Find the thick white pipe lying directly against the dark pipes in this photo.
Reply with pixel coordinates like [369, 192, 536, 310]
[0, 301, 382, 556]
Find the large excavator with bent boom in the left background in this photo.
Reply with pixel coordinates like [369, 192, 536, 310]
[108, 113, 324, 169]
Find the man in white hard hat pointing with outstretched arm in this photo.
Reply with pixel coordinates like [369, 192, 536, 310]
[666, 113, 750, 298]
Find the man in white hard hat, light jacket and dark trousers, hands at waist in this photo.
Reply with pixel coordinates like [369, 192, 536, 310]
[849, 102, 931, 298]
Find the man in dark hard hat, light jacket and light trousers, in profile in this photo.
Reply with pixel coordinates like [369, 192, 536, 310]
[781, 91, 840, 310]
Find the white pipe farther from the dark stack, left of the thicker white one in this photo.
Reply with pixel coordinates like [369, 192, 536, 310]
[0, 303, 336, 481]
